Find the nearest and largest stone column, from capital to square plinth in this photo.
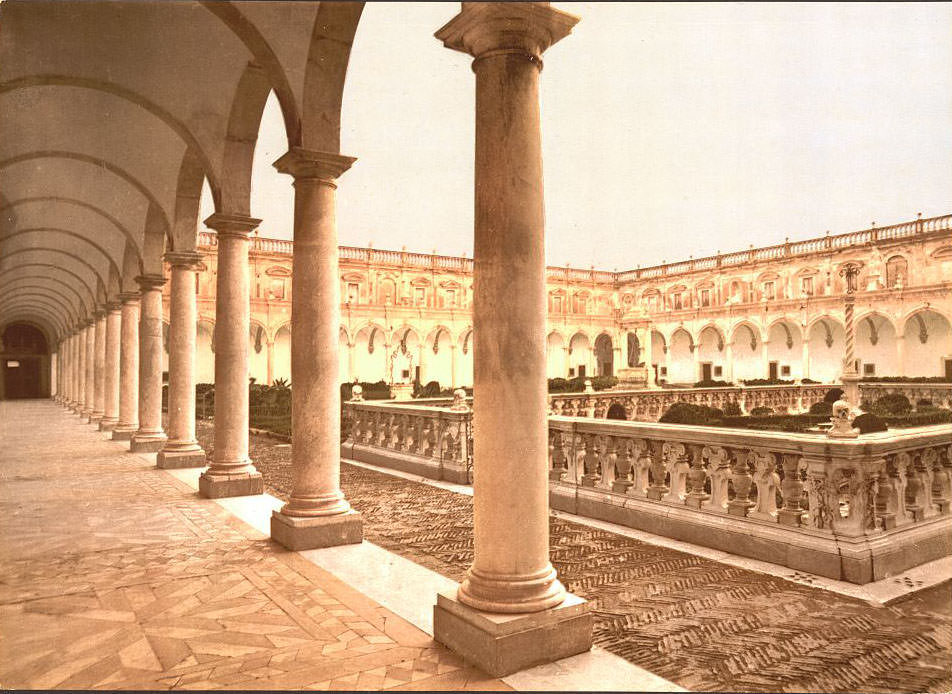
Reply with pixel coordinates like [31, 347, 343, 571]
[434, 2, 592, 676]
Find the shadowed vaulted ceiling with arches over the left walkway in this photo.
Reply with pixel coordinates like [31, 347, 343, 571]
[0, 0, 363, 344]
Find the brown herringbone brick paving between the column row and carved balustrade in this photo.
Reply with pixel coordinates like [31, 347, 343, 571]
[201, 422, 952, 692]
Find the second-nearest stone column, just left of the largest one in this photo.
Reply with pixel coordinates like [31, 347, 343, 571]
[271, 148, 363, 550]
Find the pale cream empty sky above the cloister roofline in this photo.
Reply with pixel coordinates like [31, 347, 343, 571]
[203, 2, 952, 270]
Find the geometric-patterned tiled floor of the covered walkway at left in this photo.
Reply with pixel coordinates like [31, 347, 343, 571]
[0, 401, 509, 691]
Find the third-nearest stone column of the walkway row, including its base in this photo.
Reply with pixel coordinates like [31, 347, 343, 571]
[198, 213, 264, 498]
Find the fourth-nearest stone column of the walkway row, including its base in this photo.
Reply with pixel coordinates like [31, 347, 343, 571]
[156, 252, 205, 468]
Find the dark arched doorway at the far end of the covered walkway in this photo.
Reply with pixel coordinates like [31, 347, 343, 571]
[0, 321, 50, 400]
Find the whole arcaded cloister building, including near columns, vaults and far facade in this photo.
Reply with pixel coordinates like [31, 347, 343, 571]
[0, 0, 952, 674]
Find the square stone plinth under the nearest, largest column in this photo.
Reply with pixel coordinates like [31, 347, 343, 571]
[433, 591, 594, 677]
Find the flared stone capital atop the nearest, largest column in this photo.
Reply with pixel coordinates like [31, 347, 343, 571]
[434, 2, 579, 64]
